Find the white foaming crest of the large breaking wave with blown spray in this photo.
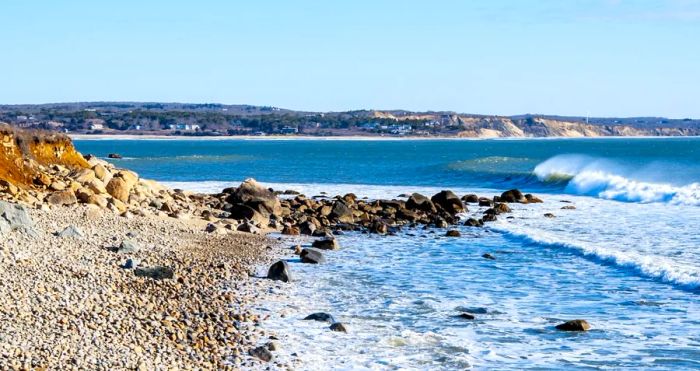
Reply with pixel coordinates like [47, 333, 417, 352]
[534, 155, 700, 206]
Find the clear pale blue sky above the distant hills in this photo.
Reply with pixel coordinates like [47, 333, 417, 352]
[0, 0, 700, 118]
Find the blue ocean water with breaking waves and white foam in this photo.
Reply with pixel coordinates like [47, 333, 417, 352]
[75, 138, 700, 370]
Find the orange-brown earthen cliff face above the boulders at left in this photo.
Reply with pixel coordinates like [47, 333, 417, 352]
[0, 125, 88, 188]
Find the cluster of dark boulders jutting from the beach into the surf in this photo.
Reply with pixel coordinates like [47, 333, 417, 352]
[200, 179, 542, 237]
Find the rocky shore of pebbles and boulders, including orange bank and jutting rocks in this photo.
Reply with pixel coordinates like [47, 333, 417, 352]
[0, 129, 572, 370]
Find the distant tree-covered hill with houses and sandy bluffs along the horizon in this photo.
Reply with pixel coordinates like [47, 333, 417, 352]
[0, 102, 700, 138]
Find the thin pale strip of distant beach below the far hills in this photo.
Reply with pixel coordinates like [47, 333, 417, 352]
[67, 134, 700, 141]
